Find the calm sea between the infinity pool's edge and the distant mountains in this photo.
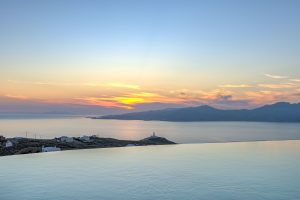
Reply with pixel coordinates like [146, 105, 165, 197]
[0, 115, 300, 143]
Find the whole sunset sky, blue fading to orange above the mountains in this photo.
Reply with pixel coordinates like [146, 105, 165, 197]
[0, 0, 300, 112]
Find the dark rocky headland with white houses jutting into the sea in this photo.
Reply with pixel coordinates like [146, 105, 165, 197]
[0, 135, 175, 156]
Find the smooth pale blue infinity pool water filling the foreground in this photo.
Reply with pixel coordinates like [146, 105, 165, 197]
[0, 141, 300, 200]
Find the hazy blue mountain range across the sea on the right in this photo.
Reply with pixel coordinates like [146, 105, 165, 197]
[96, 102, 300, 122]
